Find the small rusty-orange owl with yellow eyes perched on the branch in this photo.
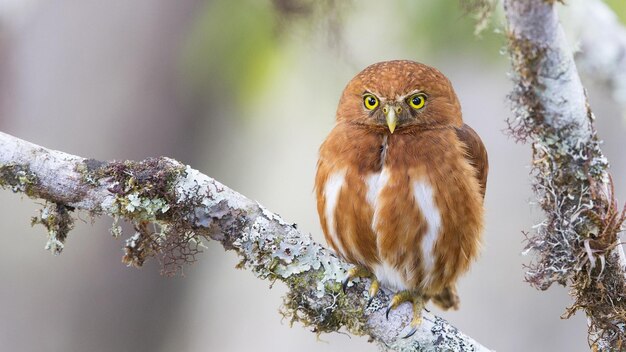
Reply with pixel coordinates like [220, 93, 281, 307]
[315, 60, 488, 337]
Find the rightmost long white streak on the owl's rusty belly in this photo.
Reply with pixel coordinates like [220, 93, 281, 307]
[413, 181, 441, 286]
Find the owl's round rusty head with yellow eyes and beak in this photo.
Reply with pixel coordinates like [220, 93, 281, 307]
[337, 60, 462, 133]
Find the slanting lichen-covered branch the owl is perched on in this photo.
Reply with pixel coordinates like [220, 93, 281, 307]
[0, 132, 489, 351]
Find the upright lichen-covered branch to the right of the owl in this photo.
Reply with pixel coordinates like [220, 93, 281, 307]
[504, 0, 626, 350]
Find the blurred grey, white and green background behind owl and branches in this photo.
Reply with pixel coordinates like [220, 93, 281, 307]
[0, 0, 626, 352]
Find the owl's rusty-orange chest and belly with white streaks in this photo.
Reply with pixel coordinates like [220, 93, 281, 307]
[340, 134, 471, 289]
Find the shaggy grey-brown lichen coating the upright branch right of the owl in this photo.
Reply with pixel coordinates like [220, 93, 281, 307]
[509, 26, 626, 350]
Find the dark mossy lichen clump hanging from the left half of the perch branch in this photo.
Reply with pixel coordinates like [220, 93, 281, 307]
[75, 158, 203, 275]
